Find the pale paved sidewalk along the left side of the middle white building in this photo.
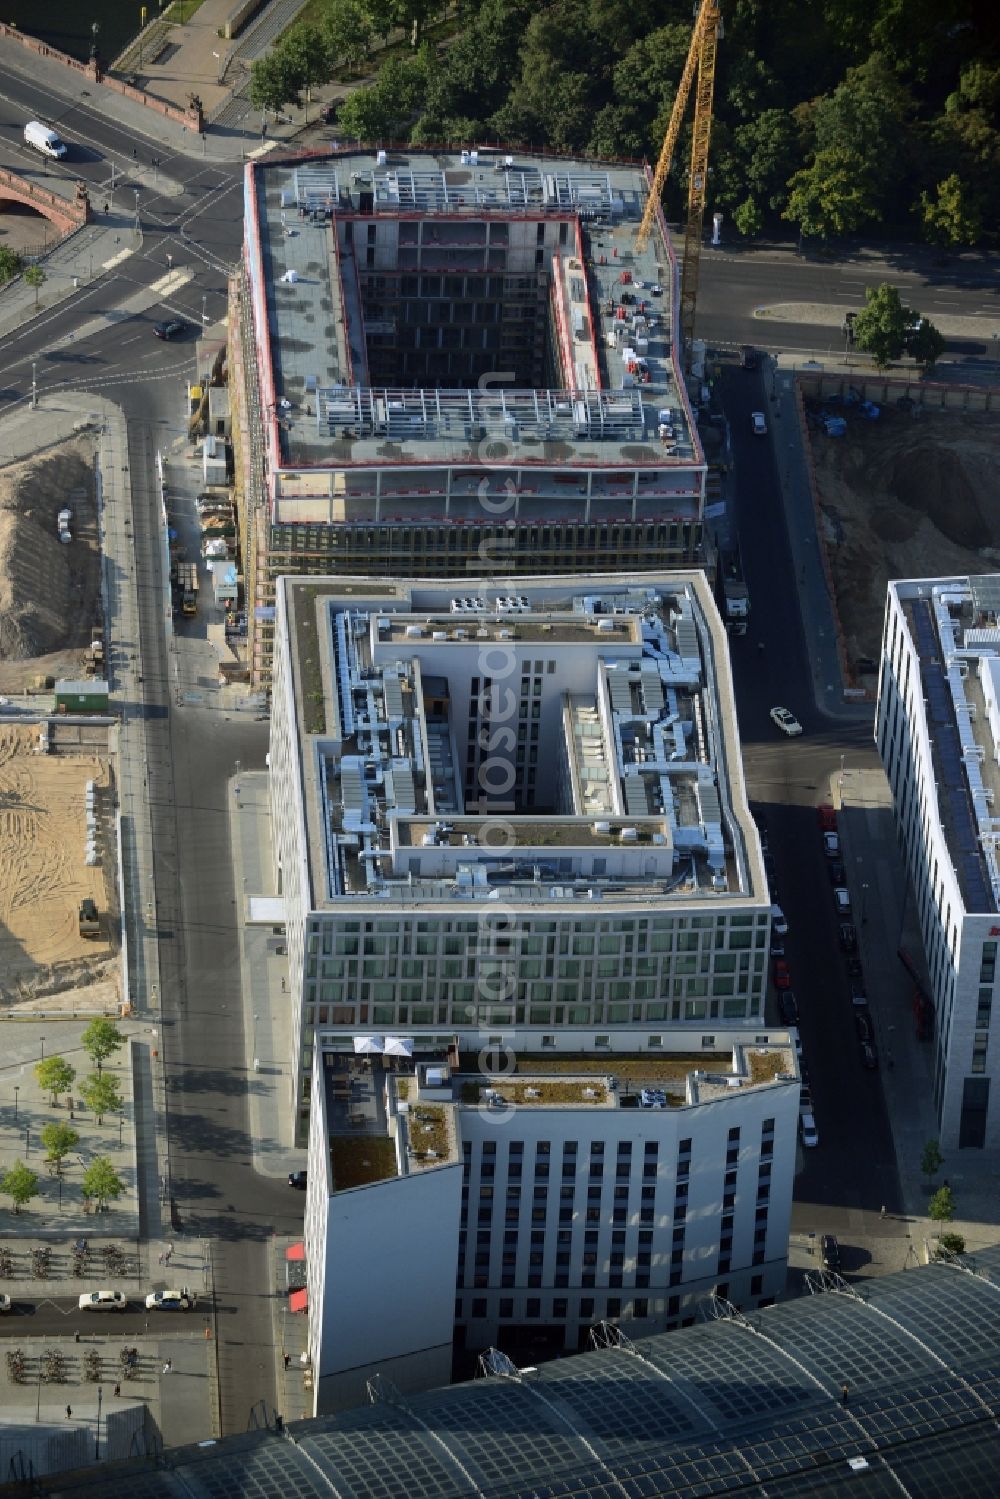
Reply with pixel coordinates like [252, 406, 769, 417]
[229, 770, 306, 1177]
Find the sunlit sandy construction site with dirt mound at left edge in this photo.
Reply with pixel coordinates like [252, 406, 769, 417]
[0, 431, 120, 1013]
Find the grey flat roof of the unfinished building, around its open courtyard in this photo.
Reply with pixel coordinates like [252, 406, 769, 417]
[246, 147, 705, 476]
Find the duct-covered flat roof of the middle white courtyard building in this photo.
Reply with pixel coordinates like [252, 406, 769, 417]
[279, 571, 769, 908]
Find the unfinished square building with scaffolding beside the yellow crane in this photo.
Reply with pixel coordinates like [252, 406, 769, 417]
[231, 150, 705, 687]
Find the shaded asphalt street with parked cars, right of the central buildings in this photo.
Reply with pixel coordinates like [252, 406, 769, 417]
[723, 367, 903, 1234]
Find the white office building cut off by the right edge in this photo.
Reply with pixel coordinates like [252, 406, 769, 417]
[877, 574, 1000, 1150]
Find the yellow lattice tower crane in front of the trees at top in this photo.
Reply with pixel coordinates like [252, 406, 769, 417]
[636, 0, 721, 348]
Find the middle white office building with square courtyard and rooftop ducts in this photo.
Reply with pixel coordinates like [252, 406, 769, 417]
[270, 571, 771, 1138]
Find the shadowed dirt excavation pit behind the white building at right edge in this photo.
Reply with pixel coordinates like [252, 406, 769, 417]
[805, 397, 1000, 668]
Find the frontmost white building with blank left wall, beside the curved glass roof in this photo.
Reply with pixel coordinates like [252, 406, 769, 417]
[304, 1027, 799, 1414]
